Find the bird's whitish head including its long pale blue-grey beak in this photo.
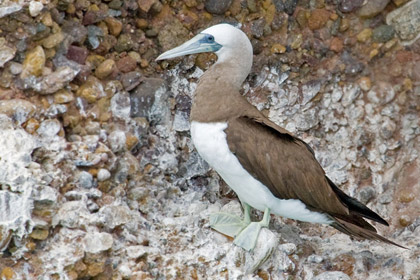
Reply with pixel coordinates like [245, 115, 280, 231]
[156, 23, 252, 67]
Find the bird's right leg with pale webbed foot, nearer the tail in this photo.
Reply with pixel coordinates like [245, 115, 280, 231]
[233, 208, 270, 251]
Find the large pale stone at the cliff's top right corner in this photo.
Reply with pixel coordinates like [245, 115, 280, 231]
[386, 0, 420, 44]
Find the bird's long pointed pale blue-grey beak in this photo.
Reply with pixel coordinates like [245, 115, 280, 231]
[156, 34, 222, 60]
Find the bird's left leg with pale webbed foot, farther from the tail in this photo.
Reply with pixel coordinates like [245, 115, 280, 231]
[210, 202, 251, 237]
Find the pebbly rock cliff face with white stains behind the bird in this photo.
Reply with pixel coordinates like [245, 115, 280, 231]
[0, 0, 420, 279]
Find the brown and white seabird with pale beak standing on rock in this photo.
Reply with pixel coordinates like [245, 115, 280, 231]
[156, 23, 405, 251]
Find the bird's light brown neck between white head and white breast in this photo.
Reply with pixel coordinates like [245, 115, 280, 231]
[190, 60, 252, 122]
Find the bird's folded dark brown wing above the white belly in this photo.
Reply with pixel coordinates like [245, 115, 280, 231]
[225, 116, 349, 216]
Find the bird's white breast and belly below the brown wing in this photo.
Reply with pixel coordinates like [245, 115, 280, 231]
[191, 121, 331, 224]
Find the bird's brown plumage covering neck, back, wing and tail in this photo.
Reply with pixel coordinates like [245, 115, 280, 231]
[191, 62, 404, 248]
